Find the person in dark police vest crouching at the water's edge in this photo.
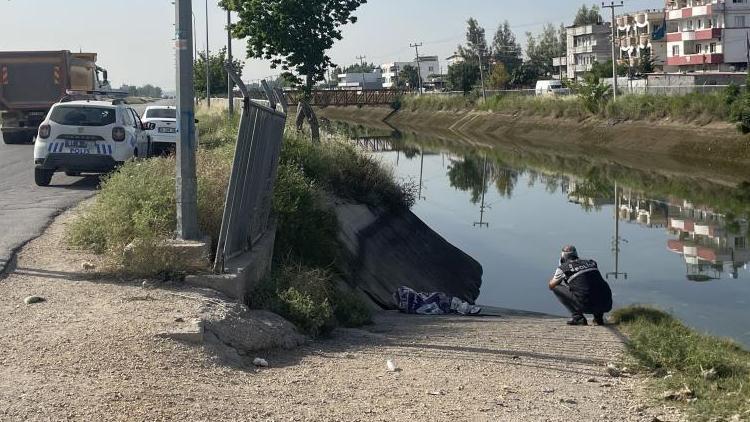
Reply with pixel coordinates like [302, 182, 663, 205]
[549, 246, 612, 325]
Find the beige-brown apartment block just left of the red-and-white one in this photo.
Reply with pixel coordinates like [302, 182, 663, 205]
[616, 10, 676, 71]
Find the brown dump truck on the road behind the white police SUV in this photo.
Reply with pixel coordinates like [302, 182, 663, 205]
[0, 50, 110, 144]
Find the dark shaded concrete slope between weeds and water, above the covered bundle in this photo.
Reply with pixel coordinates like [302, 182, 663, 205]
[333, 201, 482, 309]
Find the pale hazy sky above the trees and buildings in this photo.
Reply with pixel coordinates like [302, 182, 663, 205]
[0, 0, 664, 90]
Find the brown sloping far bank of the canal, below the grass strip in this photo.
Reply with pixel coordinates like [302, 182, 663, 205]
[319, 107, 750, 164]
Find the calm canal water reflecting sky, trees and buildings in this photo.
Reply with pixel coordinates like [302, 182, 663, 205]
[331, 118, 750, 346]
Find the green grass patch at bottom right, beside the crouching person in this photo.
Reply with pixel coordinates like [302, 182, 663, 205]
[612, 306, 750, 421]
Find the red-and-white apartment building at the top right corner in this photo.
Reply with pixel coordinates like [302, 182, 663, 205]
[666, 0, 750, 72]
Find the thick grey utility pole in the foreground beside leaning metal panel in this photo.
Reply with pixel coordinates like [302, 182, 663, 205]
[175, 0, 200, 240]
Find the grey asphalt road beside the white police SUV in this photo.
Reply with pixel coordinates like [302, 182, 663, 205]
[0, 100, 174, 275]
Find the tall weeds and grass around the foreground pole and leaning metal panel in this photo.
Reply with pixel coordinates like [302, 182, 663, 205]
[66, 111, 406, 335]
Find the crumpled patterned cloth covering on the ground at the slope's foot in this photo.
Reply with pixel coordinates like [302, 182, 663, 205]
[393, 286, 482, 315]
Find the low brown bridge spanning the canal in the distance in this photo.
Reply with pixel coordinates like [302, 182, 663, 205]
[248, 89, 406, 107]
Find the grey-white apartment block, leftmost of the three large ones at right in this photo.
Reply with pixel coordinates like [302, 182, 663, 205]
[568, 23, 612, 79]
